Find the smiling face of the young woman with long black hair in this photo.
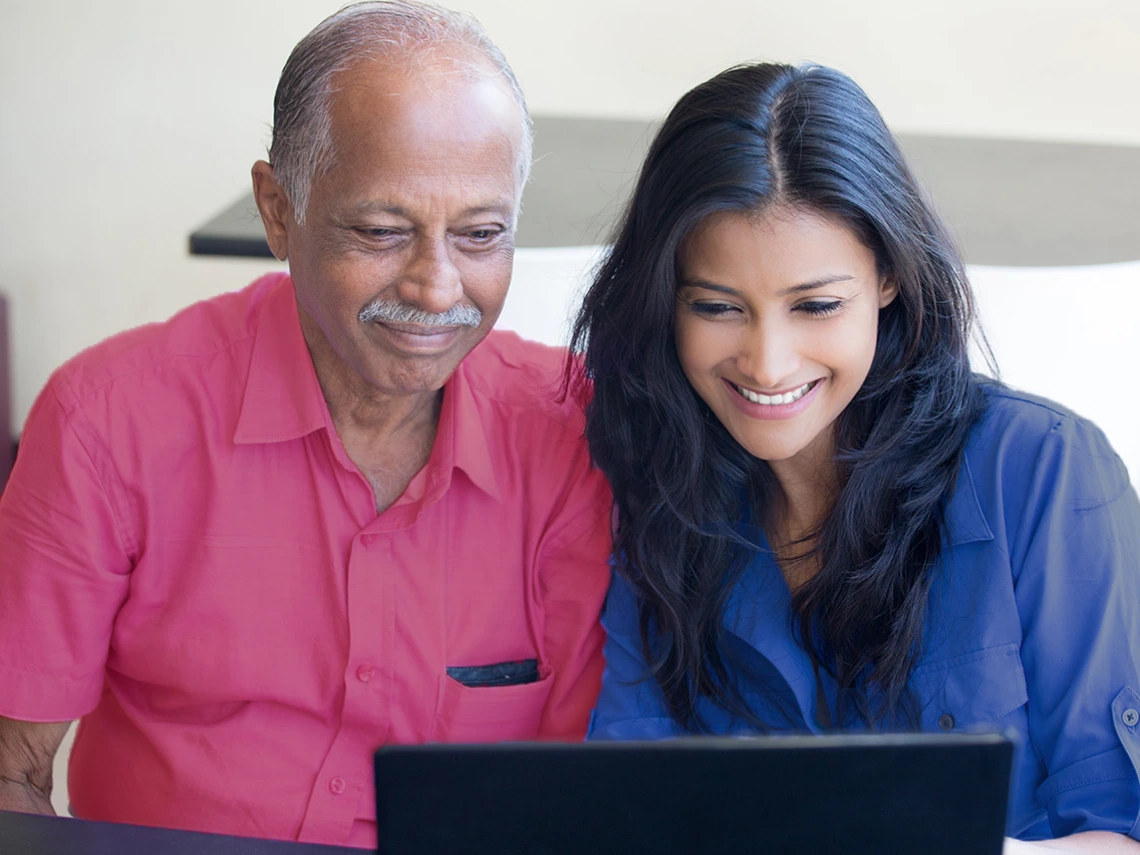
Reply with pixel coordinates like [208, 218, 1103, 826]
[676, 207, 897, 474]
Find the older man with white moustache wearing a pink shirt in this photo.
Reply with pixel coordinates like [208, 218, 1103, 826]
[0, 2, 610, 846]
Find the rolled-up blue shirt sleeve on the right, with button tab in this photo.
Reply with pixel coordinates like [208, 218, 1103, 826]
[1005, 416, 1140, 838]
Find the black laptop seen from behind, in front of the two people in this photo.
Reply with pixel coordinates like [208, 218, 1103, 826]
[375, 734, 1012, 855]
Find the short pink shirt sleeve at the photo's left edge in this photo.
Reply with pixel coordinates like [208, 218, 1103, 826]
[0, 375, 131, 722]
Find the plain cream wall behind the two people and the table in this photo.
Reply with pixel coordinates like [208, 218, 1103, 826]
[0, 0, 1140, 422]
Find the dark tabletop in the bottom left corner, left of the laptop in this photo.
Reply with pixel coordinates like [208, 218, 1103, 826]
[0, 811, 361, 855]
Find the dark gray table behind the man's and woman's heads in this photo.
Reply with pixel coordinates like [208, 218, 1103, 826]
[190, 116, 1140, 267]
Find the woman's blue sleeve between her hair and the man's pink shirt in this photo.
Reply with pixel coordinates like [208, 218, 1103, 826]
[586, 572, 682, 741]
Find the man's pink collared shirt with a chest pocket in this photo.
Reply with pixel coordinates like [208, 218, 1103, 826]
[0, 275, 610, 846]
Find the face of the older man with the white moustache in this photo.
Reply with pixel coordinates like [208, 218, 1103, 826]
[280, 62, 522, 396]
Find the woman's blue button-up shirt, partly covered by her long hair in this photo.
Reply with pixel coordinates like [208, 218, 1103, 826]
[589, 386, 1140, 839]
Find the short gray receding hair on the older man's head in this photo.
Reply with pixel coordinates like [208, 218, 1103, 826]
[269, 0, 532, 223]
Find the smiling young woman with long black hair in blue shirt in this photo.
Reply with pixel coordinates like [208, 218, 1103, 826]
[575, 65, 1140, 852]
